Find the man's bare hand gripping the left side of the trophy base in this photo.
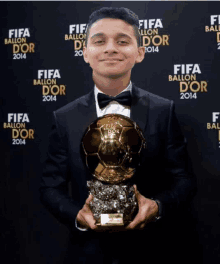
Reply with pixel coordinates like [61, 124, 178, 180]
[76, 194, 97, 230]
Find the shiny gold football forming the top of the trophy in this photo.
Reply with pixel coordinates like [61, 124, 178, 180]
[82, 114, 146, 184]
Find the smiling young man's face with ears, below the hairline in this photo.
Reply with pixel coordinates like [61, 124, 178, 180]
[83, 18, 145, 78]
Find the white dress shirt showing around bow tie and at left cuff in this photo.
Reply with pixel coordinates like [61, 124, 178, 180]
[75, 81, 132, 231]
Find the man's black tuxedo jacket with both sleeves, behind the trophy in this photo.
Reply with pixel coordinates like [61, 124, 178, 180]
[40, 85, 195, 232]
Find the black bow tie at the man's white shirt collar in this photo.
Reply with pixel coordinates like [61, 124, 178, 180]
[98, 91, 131, 108]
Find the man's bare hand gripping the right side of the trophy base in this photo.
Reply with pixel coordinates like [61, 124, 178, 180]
[126, 185, 159, 229]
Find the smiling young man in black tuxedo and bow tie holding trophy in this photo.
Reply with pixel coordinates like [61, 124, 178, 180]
[40, 8, 195, 263]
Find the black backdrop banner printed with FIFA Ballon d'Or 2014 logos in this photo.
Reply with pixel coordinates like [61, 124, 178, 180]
[0, 1, 220, 264]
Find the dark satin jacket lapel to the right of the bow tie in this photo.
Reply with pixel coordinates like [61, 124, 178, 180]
[131, 85, 149, 132]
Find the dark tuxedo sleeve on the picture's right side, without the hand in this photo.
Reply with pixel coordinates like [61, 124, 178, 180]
[153, 101, 196, 217]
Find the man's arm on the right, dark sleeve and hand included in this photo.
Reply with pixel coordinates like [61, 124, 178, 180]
[127, 101, 196, 229]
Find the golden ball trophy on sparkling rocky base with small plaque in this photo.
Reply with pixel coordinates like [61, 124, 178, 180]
[82, 114, 146, 226]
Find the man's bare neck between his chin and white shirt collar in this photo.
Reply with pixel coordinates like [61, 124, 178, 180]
[93, 72, 131, 96]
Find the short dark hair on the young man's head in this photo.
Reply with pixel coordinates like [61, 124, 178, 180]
[85, 7, 141, 47]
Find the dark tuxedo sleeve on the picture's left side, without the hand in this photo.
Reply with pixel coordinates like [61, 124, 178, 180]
[39, 112, 81, 231]
